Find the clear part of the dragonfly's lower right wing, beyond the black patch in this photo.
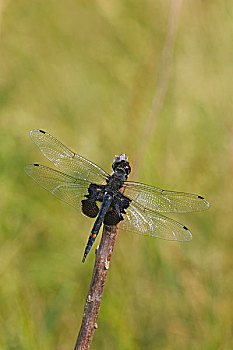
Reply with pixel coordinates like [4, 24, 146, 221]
[119, 202, 192, 241]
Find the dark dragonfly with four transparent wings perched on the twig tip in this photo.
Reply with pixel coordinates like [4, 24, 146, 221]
[24, 129, 209, 262]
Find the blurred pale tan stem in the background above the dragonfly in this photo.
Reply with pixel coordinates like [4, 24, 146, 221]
[133, 0, 183, 176]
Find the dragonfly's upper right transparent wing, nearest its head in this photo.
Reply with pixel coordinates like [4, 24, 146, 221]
[124, 181, 209, 213]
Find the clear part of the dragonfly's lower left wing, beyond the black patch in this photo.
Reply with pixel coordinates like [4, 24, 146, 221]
[24, 164, 90, 209]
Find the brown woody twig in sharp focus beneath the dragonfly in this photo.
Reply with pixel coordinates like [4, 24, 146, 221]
[74, 226, 117, 350]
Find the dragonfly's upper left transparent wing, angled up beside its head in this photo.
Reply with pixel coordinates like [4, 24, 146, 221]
[30, 130, 108, 184]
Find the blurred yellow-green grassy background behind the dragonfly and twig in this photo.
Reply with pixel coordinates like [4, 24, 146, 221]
[0, 0, 233, 350]
